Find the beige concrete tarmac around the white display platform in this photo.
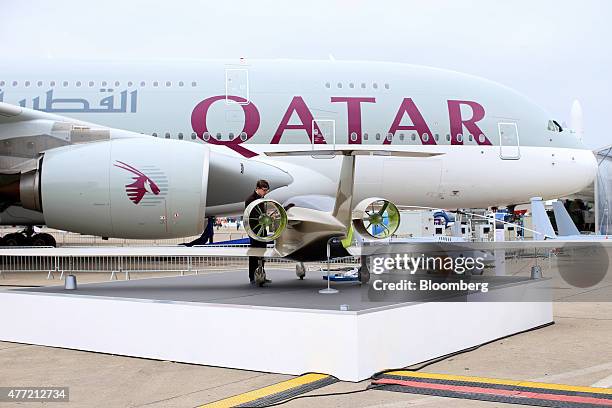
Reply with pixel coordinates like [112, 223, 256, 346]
[0, 271, 612, 408]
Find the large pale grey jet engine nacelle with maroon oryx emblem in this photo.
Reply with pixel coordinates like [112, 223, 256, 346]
[20, 138, 210, 239]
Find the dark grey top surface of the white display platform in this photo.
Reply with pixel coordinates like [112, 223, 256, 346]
[11, 269, 540, 313]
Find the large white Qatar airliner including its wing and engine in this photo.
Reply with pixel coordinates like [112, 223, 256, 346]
[0, 60, 596, 247]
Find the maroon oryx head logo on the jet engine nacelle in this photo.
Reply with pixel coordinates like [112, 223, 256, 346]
[114, 160, 168, 206]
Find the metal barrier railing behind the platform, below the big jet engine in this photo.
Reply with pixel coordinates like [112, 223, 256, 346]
[0, 246, 359, 279]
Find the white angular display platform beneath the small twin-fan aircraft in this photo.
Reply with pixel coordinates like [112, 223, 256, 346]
[0, 271, 553, 381]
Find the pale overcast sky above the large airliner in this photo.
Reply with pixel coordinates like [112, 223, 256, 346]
[0, 0, 612, 148]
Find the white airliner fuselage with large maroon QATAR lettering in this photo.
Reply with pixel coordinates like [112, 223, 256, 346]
[0, 60, 596, 215]
